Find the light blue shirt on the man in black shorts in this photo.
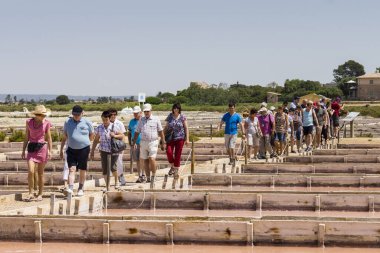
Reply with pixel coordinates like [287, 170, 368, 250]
[63, 118, 94, 149]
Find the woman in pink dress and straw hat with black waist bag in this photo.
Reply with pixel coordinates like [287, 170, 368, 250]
[21, 105, 52, 201]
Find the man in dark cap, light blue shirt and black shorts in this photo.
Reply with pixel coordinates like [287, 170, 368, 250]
[59, 105, 94, 196]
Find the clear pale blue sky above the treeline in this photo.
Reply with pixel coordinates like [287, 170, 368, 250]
[0, 0, 380, 96]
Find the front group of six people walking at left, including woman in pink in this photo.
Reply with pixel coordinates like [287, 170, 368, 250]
[21, 103, 189, 201]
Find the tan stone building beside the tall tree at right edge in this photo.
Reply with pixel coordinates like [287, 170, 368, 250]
[357, 72, 380, 100]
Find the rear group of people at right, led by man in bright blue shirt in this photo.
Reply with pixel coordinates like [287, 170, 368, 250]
[218, 97, 344, 164]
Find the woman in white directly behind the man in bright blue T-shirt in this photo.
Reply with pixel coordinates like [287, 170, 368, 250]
[244, 109, 262, 160]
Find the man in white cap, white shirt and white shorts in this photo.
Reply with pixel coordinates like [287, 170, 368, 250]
[132, 104, 166, 182]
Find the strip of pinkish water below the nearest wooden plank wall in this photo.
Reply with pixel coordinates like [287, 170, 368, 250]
[0, 242, 380, 253]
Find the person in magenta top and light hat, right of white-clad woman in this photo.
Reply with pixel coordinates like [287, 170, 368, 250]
[258, 107, 276, 159]
